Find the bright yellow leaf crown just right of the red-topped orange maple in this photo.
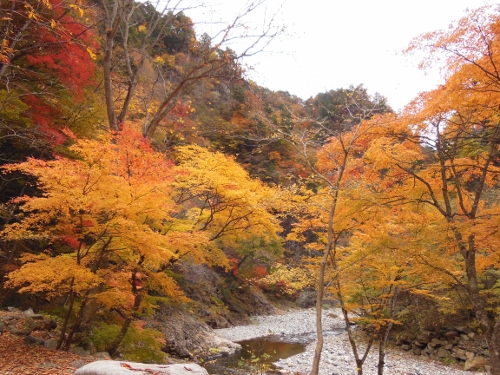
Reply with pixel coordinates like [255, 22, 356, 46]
[174, 146, 279, 244]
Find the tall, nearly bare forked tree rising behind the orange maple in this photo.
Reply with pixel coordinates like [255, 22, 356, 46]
[102, 0, 281, 138]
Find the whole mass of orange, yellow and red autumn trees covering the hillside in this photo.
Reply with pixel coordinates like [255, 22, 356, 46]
[0, 0, 500, 375]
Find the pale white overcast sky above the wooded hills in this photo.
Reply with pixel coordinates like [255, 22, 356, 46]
[186, 0, 493, 110]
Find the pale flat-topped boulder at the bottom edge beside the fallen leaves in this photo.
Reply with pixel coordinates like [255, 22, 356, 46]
[75, 361, 208, 375]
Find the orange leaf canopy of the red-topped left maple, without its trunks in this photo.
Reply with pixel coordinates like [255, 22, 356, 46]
[1, 127, 188, 303]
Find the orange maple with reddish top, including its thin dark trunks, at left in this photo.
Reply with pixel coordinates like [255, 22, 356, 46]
[1, 127, 225, 352]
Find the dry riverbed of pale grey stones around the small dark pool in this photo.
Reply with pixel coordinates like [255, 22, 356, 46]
[215, 309, 487, 375]
